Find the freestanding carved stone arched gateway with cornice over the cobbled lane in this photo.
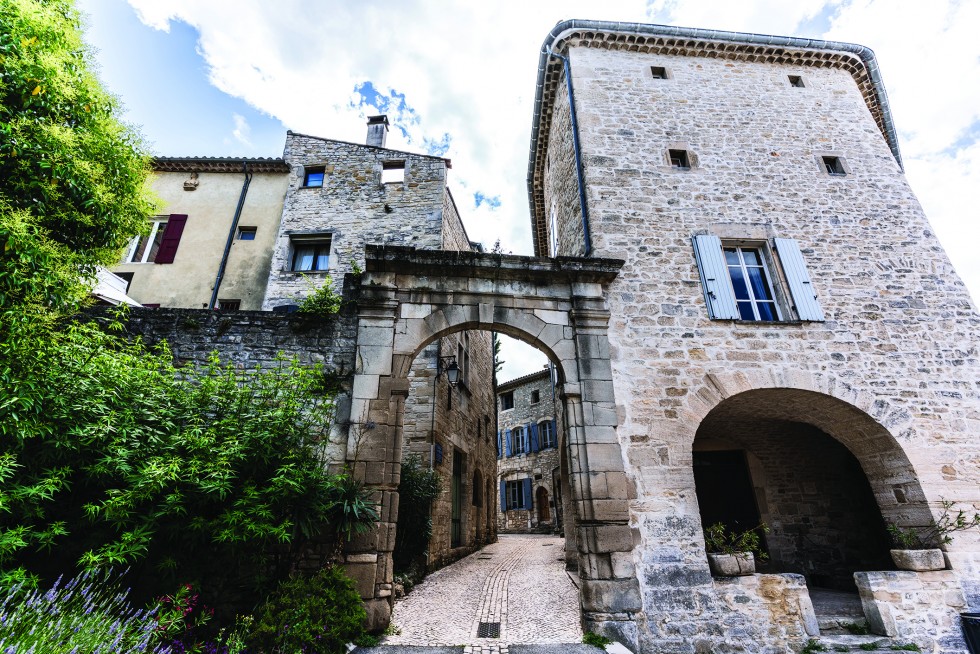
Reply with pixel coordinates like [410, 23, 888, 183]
[346, 246, 640, 635]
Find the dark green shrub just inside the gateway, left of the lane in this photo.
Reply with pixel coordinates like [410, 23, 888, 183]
[393, 456, 442, 572]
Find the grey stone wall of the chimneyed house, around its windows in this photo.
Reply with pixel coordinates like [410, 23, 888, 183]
[263, 132, 447, 309]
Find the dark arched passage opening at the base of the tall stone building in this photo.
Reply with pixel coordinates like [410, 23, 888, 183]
[693, 388, 928, 590]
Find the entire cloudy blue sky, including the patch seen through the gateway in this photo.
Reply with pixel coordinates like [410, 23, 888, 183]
[74, 0, 980, 378]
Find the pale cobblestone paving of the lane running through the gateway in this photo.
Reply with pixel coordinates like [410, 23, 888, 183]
[382, 534, 582, 654]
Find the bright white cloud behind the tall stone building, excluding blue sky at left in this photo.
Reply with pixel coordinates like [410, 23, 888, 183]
[130, 0, 980, 376]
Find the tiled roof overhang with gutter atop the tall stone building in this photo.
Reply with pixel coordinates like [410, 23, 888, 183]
[527, 20, 902, 256]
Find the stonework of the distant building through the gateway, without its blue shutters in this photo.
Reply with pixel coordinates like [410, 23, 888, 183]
[502, 369, 563, 532]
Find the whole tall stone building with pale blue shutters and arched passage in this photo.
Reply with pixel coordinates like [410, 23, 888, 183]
[528, 21, 980, 653]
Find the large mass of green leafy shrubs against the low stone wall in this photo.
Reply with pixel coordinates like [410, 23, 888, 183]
[0, 324, 377, 595]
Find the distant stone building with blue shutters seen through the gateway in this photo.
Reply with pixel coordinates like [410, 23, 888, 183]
[497, 366, 563, 533]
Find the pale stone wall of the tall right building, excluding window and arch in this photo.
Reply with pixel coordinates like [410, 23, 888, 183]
[537, 43, 980, 652]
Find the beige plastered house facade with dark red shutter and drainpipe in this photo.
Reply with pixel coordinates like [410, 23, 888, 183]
[112, 157, 289, 311]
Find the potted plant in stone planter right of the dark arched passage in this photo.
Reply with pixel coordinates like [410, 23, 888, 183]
[888, 498, 980, 572]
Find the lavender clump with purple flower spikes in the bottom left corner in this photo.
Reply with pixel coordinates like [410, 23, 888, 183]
[0, 571, 169, 654]
